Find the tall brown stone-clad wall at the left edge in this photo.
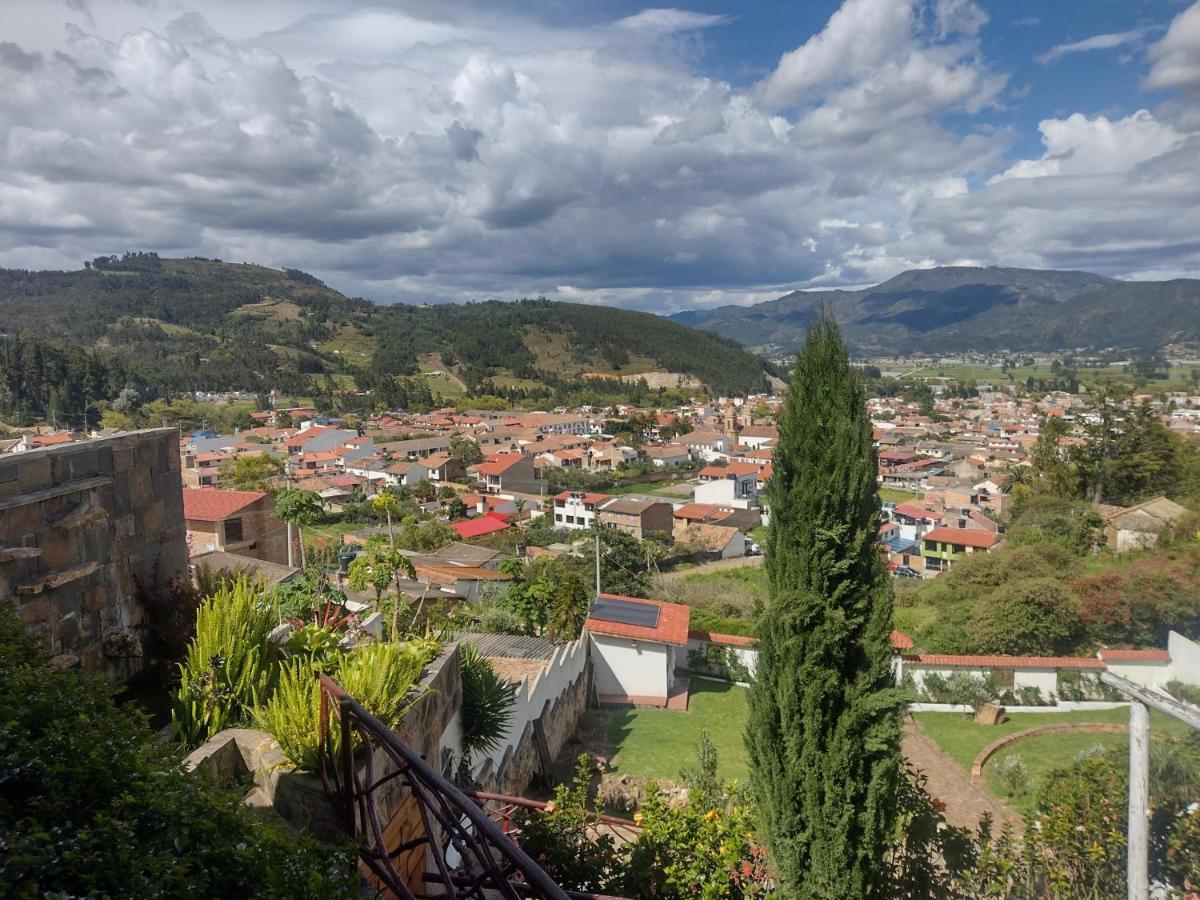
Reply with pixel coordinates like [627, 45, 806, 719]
[0, 428, 187, 682]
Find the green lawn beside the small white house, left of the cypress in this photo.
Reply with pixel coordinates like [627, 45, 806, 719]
[600, 679, 748, 781]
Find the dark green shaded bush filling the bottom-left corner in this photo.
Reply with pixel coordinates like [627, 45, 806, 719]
[0, 608, 358, 898]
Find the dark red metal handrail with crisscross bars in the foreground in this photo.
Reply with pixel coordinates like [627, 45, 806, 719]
[319, 674, 568, 900]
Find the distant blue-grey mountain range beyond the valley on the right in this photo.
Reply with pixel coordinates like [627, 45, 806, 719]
[671, 266, 1200, 356]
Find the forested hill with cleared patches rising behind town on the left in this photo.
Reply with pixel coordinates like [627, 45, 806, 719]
[0, 253, 770, 427]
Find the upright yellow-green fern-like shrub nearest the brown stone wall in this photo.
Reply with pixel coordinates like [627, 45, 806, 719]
[172, 576, 280, 746]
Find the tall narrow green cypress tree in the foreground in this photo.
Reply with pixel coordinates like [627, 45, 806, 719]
[746, 312, 902, 900]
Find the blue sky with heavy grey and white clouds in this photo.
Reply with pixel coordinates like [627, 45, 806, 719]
[0, 0, 1200, 313]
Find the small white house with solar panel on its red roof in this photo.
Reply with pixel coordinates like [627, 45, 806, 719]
[583, 594, 691, 708]
